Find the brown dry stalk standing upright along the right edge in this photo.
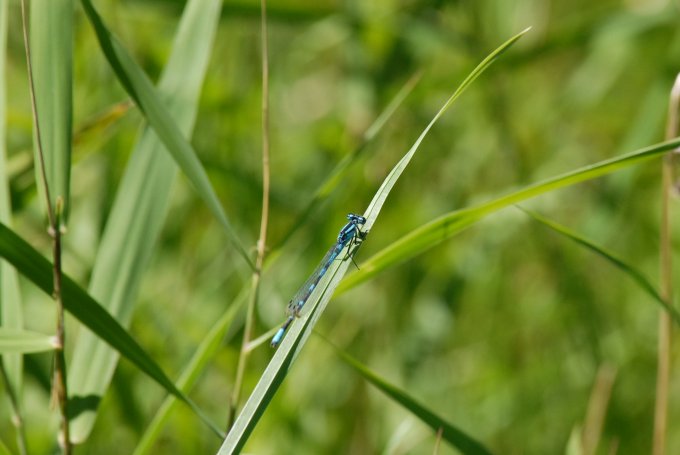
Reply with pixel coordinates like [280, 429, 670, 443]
[652, 75, 680, 455]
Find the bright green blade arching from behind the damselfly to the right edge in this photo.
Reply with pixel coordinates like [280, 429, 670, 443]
[338, 135, 680, 292]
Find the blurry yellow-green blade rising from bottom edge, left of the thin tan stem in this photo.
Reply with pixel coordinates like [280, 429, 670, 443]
[133, 294, 246, 455]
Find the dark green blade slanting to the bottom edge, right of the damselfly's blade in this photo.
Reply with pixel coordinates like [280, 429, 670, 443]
[336, 348, 491, 455]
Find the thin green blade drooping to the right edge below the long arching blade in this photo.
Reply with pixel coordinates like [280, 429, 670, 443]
[521, 209, 680, 325]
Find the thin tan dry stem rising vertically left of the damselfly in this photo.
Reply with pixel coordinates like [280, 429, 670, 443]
[227, 0, 269, 428]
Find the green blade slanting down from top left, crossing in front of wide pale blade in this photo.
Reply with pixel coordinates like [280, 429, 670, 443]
[81, 0, 254, 269]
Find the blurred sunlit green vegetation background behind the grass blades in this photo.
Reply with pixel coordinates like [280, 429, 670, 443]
[0, 0, 680, 454]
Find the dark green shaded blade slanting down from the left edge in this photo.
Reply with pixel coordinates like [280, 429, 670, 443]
[0, 223, 221, 440]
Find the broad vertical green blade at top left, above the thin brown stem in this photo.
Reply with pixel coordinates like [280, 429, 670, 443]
[30, 0, 74, 224]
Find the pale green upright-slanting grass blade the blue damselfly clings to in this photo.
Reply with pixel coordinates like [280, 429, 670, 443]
[218, 30, 527, 455]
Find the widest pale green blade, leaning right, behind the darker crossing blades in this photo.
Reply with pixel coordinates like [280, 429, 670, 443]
[69, 0, 221, 442]
